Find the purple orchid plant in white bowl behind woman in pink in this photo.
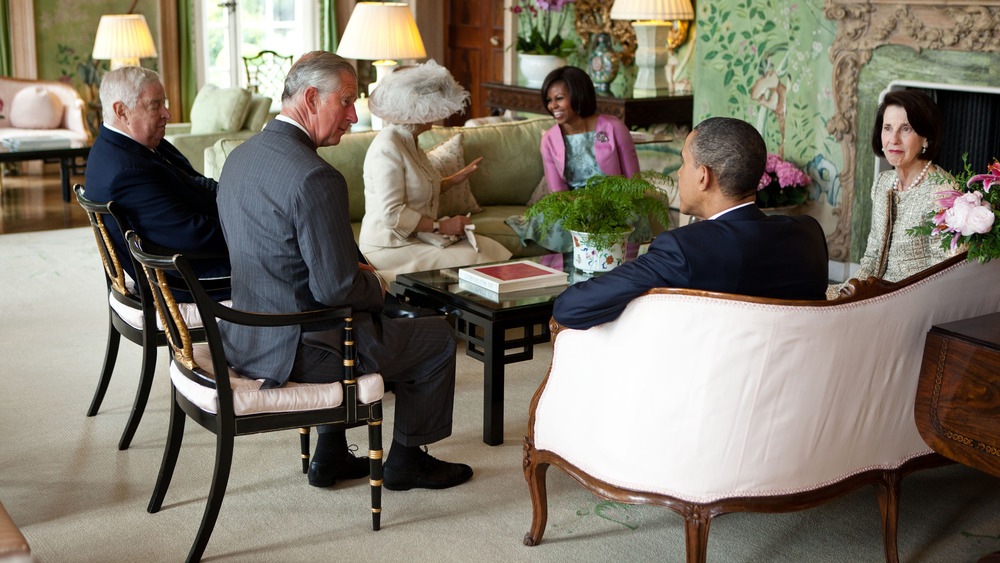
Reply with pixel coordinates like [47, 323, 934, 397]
[510, 0, 575, 57]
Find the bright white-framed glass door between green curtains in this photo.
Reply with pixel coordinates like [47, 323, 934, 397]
[195, 0, 319, 88]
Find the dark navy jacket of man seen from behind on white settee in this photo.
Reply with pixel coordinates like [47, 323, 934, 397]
[552, 205, 828, 329]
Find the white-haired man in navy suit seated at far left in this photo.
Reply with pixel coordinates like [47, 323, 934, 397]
[86, 66, 229, 284]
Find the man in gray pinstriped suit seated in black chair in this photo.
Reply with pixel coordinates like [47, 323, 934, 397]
[218, 51, 472, 490]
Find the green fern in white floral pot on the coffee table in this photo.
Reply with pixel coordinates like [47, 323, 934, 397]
[525, 171, 674, 272]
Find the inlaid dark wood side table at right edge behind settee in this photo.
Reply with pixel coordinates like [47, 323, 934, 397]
[914, 313, 1000, 477]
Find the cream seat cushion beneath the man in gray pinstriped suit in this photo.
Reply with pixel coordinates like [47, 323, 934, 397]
[170, 342, 385, 416]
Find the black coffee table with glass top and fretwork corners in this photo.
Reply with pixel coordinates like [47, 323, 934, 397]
[390, 254, 586, 446]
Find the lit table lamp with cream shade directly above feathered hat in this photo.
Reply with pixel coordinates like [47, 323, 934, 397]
[337, 2, 427, 93]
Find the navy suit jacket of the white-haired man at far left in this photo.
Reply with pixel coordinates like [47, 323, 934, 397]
[86, 125, 229, 279]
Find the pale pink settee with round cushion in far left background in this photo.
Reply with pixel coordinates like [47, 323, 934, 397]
[0, 77, 90, 148]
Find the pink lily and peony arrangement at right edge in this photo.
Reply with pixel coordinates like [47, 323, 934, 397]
[907, 156, 1000, 262]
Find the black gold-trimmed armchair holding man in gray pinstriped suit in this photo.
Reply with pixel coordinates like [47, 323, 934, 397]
[127, 232, 384, 561]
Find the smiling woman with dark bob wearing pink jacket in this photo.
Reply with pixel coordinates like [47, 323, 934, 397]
[541, 66, 639, 192]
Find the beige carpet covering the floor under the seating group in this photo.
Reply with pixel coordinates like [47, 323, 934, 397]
[0, 229, 1000, 562]
